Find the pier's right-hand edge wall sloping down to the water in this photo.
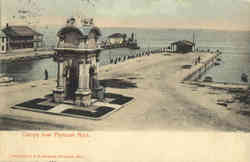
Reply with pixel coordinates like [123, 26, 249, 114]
[183, 53, 221, 81]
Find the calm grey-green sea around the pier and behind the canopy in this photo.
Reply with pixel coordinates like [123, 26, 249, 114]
[0, 27, 250, 84]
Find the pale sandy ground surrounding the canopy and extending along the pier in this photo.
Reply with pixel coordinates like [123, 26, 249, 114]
[0, 54, 250, 131]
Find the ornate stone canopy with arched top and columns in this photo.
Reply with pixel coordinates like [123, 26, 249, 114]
[53, 19, 103, 107]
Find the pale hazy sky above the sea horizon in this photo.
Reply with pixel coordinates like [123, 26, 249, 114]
[2, 0, 250, 30]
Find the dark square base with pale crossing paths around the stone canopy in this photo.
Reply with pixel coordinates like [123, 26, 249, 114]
[12, 93, 133, 120]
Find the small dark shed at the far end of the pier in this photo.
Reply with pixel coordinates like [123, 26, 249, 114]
[170, 40, 195, 53]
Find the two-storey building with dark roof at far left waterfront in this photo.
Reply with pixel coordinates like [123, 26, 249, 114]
[0, 24, 43, 53]
